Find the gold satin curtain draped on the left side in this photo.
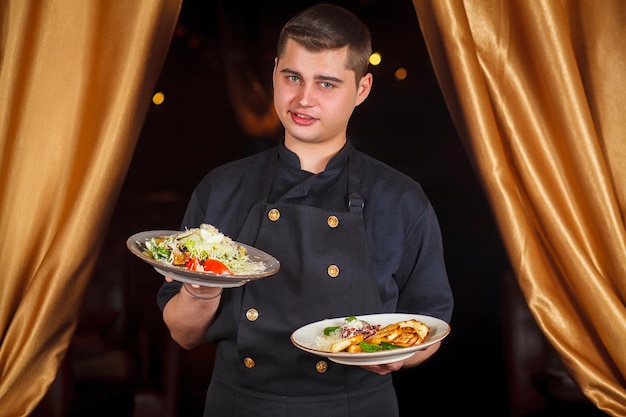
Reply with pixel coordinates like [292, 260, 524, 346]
[0, 0, 181, 416]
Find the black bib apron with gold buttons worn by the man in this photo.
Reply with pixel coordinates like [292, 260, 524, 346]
[204, 148, 398, 417]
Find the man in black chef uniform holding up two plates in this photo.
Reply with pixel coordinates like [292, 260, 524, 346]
[159, 5, 453, 417]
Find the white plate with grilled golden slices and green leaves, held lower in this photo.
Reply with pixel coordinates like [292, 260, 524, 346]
[291, 313, 450, 366]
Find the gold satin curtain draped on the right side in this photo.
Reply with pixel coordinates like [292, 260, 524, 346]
[413, 0, 626, 416]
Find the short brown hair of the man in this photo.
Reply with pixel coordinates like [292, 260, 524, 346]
[277, 4, 372, 83]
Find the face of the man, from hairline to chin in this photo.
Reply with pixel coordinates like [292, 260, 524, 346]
[273, 40, 372, 149]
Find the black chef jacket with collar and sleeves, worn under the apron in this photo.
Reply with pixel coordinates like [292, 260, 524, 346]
[158, 142, 453, 323]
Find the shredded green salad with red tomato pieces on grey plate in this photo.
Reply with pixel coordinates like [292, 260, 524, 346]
[144, 223, 265, 275]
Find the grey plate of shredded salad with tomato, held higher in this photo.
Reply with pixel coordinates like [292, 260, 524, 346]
[126, 224, 280, 288]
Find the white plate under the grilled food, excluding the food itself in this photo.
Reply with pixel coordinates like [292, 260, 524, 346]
[291, 313, 450, 366]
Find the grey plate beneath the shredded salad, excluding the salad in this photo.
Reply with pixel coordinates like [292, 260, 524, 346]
[126, 230, 280, 288]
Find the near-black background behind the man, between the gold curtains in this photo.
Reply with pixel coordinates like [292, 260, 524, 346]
[58, 0, 540, 416]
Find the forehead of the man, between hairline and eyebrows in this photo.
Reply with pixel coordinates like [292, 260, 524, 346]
[278, 39, 354, 78]
